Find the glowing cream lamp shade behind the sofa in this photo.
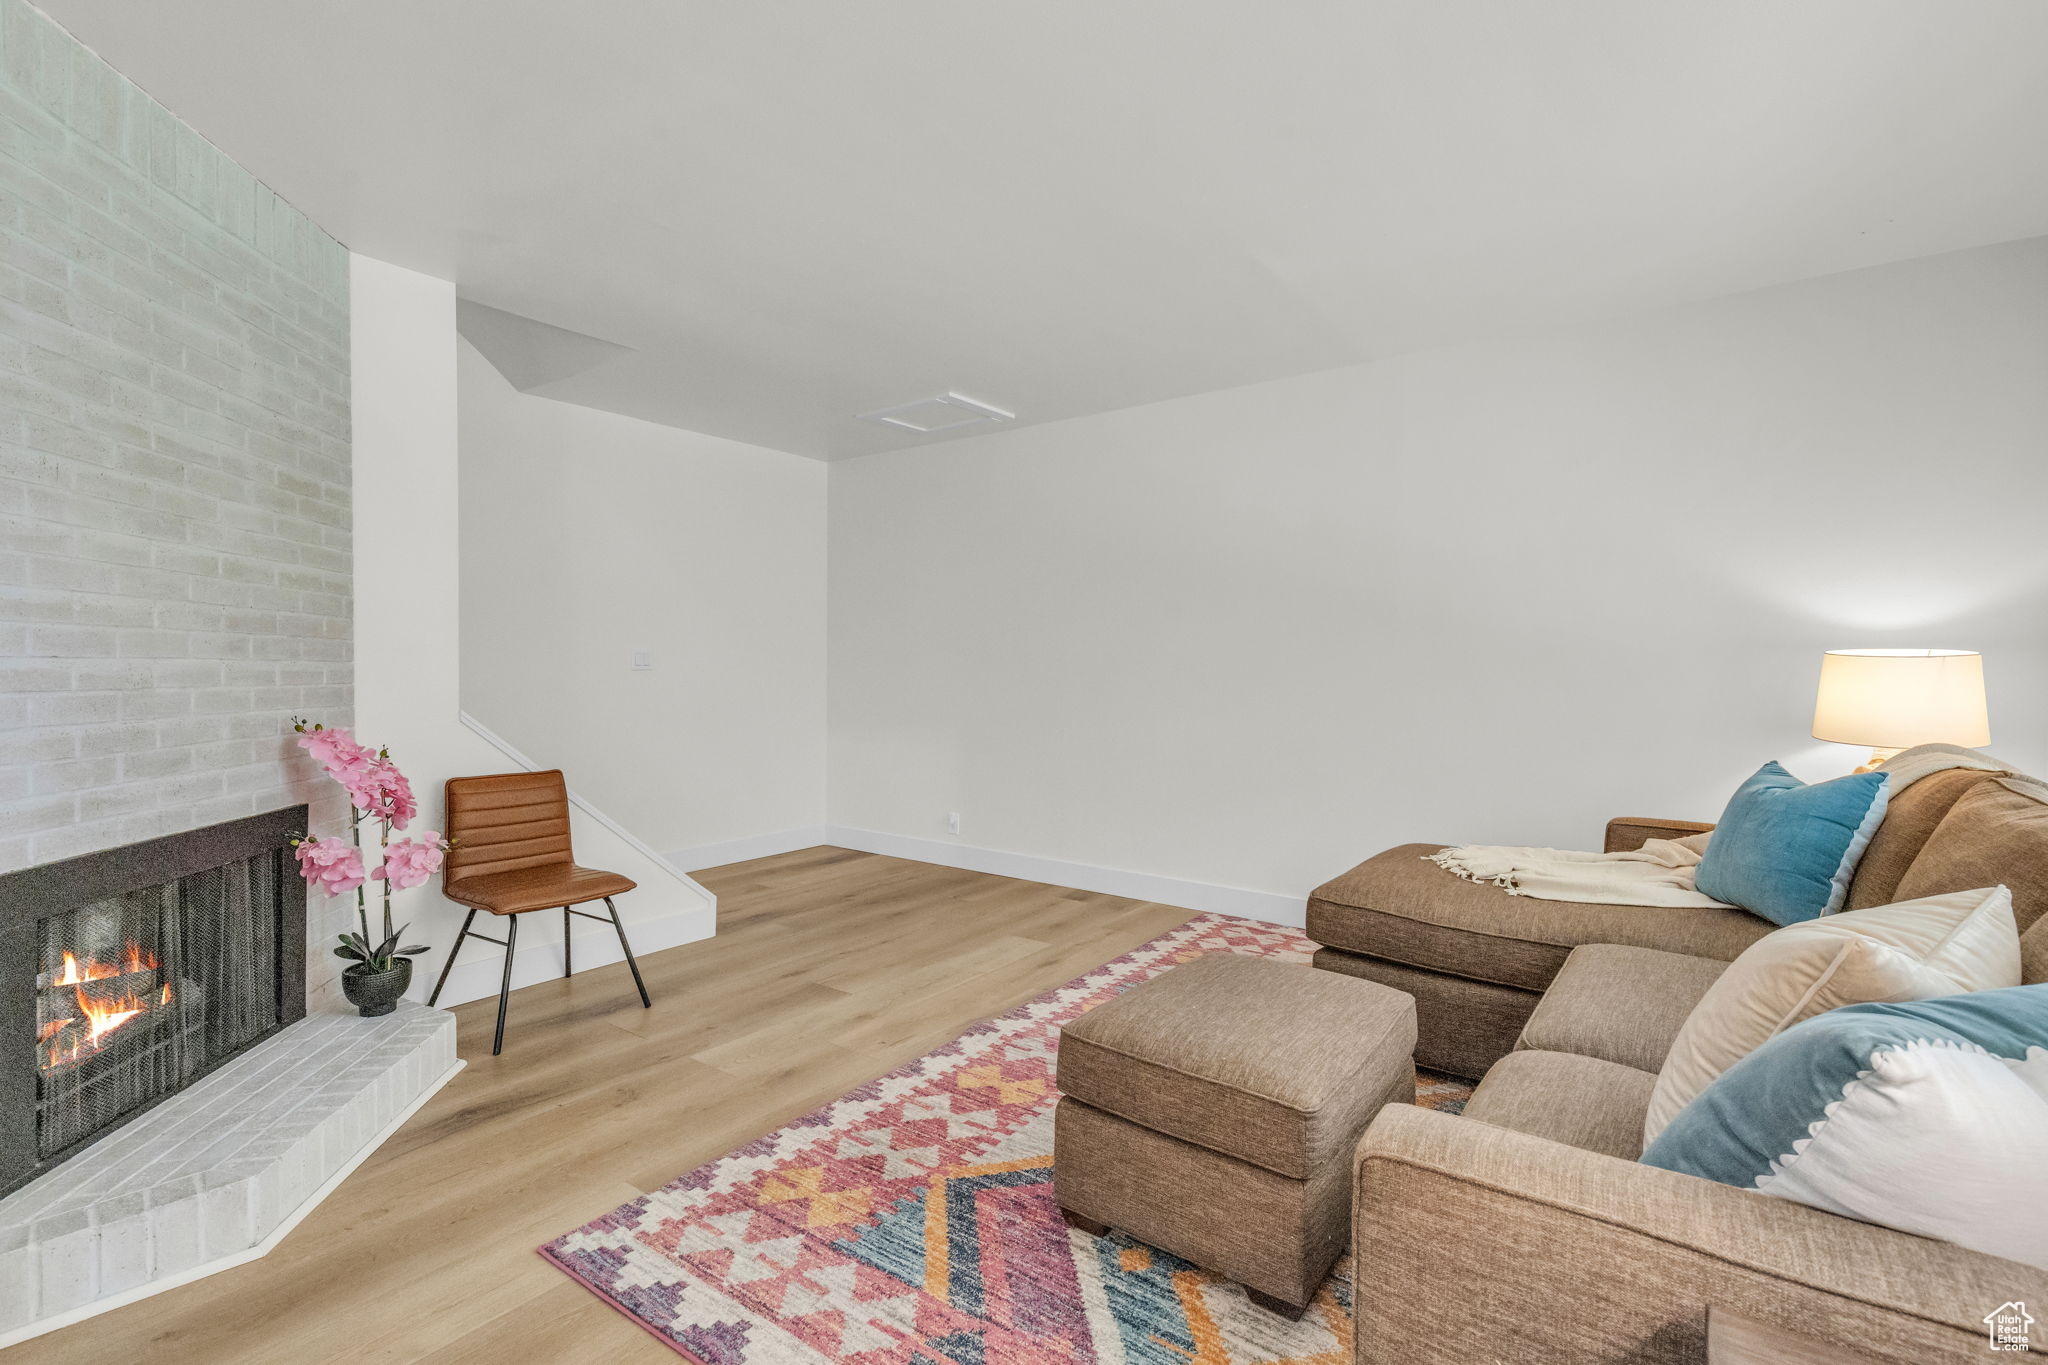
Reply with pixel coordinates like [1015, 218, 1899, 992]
[1812, 649, 1991, 749]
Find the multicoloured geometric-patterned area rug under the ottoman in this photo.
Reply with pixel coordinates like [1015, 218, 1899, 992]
[541, 915, 1470, 1365]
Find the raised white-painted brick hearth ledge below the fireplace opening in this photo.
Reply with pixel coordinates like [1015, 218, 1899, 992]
[0, 1001, 463, 1347]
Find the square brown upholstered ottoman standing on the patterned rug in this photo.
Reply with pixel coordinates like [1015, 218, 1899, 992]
[1053, 954, 1415, 1318]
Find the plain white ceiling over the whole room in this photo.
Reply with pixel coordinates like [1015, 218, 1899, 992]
[45, 0, 2048, 458]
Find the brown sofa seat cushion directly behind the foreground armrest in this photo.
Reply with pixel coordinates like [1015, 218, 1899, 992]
[1464, 1052, 1657, 1160]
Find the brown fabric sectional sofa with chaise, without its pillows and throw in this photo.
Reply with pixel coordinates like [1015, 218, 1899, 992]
[1309, 769, 2048, 1365]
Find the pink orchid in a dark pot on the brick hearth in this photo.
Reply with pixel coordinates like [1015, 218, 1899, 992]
[291, 718, 449, 972]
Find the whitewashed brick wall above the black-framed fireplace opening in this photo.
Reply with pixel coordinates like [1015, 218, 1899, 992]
[0, 0, 352, 980]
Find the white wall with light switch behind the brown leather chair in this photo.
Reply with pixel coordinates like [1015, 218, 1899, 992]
[457, 342, 825, 866]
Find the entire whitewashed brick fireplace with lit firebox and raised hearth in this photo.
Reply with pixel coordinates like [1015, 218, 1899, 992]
[0, 0, 461, 1359]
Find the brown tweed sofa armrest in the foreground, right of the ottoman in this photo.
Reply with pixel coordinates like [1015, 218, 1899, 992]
[1352, 1105, 2048, 1365]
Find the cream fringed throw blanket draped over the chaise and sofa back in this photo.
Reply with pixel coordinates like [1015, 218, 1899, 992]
[1430, 745, 2013, 909]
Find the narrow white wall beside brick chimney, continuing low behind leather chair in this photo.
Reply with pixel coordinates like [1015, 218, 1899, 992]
[346, 256, 715, 1005]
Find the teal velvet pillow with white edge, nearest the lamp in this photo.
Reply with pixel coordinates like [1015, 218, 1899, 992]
[1694, 761, 1890, 925]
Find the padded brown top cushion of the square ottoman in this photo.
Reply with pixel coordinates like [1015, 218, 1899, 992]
[1057, 954, 1415, 1181]
